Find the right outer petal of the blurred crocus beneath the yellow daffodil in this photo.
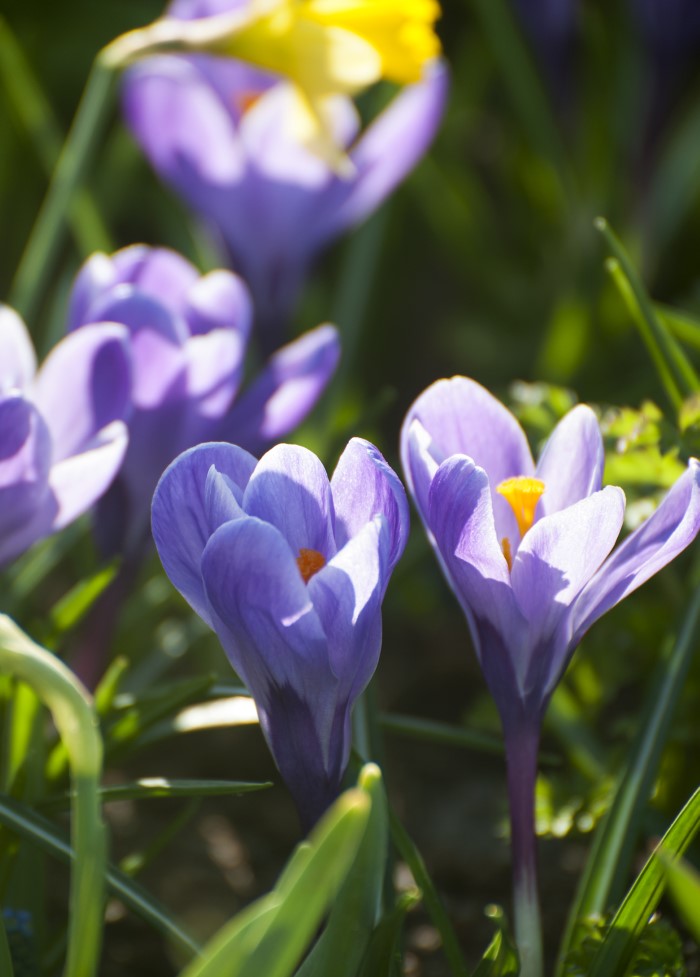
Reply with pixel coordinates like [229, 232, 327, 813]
[318, 62, 449, 238]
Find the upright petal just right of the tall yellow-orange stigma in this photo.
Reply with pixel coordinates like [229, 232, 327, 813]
[535, 404, 605, 517]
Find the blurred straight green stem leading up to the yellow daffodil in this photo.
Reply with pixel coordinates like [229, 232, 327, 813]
[9, 55, 116, 328]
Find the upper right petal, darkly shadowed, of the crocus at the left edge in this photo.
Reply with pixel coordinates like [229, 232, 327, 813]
[34, 323, 131, 462]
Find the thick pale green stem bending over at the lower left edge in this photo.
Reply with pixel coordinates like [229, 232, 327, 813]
[0, 615, 106, 977]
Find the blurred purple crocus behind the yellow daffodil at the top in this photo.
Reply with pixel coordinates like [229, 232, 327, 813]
[123, 0, 447, 349]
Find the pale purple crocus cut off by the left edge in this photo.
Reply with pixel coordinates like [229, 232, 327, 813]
[0, 306, 130, 565]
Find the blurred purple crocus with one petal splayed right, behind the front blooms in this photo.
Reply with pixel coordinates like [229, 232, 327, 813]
[68, 245, 339, 554]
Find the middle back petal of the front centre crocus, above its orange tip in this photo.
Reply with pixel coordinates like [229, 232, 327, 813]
[243, 444, 336, 560]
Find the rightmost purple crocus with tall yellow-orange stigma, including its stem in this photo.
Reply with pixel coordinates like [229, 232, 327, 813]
[402, 377, 700, 973]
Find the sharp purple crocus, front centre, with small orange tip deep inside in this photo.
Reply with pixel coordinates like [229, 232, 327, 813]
[152, 439, 408, 829]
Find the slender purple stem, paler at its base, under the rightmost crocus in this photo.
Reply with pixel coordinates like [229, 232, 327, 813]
[506, 724, 543, 977]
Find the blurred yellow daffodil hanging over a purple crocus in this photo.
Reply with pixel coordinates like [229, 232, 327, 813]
[117, 0, 440, 173]
